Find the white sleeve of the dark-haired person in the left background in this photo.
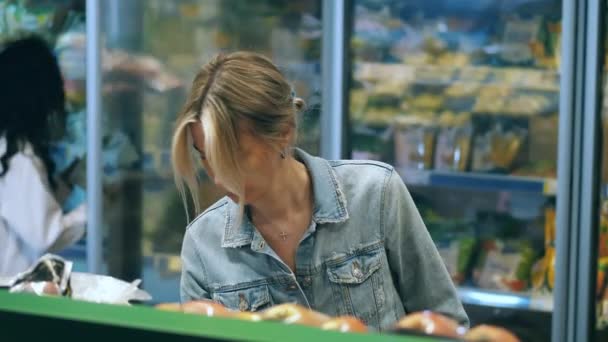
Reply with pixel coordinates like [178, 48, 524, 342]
[0, 153, 85, 254]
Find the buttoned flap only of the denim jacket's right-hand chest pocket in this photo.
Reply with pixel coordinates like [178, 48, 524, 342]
[327, 251, 382, 284]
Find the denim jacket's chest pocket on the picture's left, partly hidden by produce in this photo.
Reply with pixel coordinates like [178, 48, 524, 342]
[212, 285, 272, 311]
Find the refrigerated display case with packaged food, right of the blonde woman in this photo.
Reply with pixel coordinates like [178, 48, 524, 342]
[343, 0, 608, 341]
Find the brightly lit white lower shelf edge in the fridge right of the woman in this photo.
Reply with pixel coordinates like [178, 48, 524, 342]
[458, 287, 553, 312]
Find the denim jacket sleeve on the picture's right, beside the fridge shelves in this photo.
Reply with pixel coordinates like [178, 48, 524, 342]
[381, 170, 469, 326]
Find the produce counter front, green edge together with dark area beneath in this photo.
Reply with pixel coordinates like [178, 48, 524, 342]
[0, 290, 448, 342]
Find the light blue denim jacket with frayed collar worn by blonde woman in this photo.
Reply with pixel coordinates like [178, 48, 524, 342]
[181, 149, 468, 330]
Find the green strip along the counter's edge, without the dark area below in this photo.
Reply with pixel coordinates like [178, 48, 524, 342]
[0, 290, 446, 342]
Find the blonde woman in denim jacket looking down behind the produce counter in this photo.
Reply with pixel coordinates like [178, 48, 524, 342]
[173, 52, 468, 329]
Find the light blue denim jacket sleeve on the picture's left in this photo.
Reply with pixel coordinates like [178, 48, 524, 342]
[180, 228, 210, 302]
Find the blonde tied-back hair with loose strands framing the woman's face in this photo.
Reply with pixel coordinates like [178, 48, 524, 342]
[171, 52, 304, 220]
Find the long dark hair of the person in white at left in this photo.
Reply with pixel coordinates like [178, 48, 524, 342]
[0, 35, 66, 188]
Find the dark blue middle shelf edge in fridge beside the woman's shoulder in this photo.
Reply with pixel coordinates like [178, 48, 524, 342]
[397, 169, 557, 196]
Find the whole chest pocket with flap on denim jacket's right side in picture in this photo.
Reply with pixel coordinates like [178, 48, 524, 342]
[327, 249, 385, 327]
